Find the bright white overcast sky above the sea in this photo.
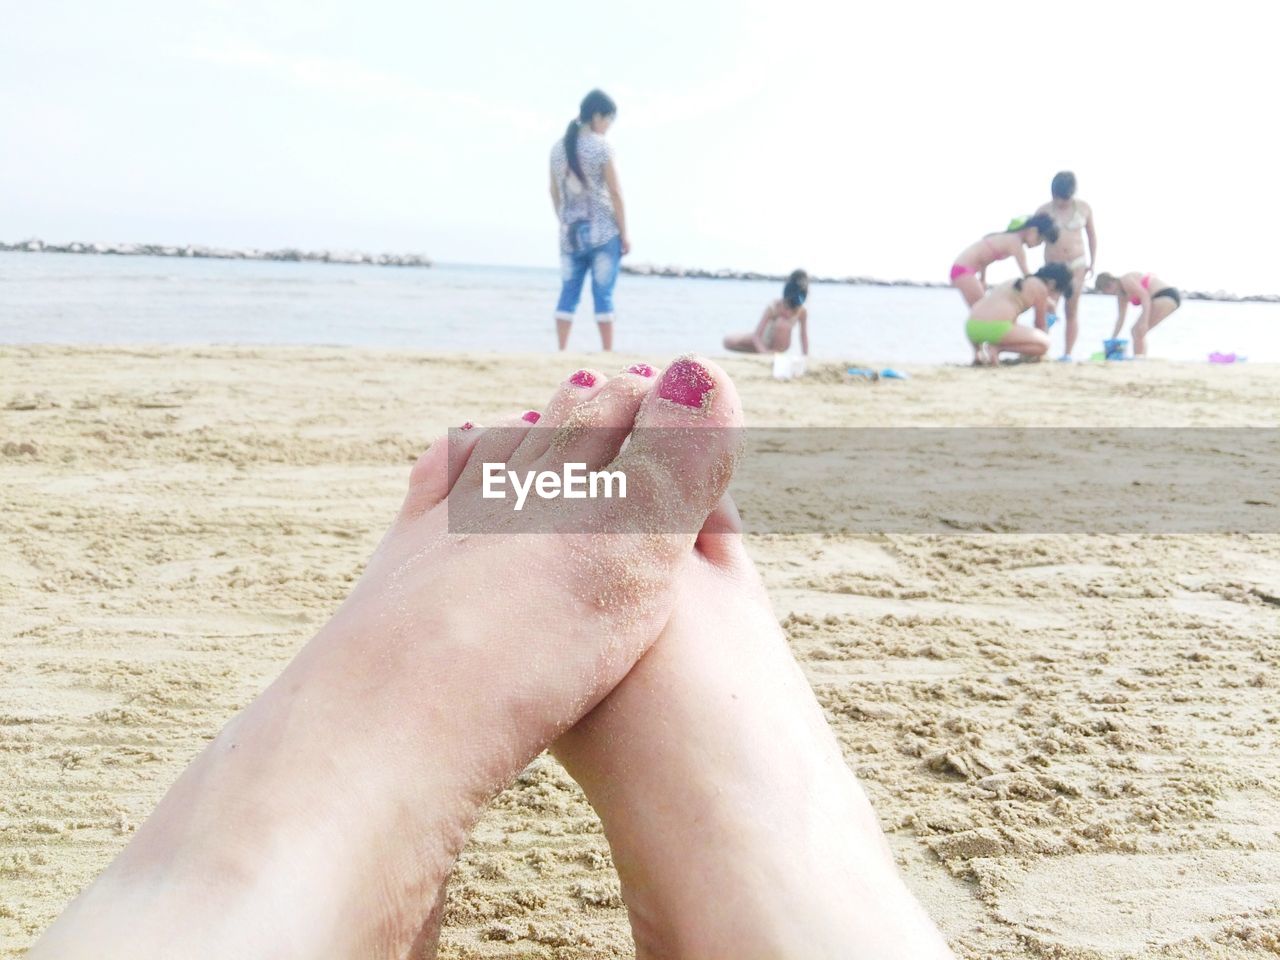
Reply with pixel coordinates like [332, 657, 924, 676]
[0, 0, 1280, 293]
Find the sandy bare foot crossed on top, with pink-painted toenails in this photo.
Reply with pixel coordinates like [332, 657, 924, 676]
[31, 360, 740, 960]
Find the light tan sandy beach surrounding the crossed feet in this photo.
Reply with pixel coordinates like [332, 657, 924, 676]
[0, 347, 1280, 960]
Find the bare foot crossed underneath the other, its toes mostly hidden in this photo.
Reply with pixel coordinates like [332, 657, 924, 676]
[554, 498, 952, 960]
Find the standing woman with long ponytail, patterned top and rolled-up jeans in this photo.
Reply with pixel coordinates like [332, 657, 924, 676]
[552, 90, 631, 351]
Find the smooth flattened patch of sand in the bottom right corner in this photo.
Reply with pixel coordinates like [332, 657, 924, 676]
[997, 850, 1280, 957]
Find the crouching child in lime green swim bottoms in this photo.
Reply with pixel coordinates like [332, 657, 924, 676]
[964, 264, 1071, 366]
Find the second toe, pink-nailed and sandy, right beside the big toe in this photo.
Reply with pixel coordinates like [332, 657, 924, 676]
[543, 364, 658, 470]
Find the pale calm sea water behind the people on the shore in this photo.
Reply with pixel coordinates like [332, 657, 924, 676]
[0, 253, 1280, 364]
